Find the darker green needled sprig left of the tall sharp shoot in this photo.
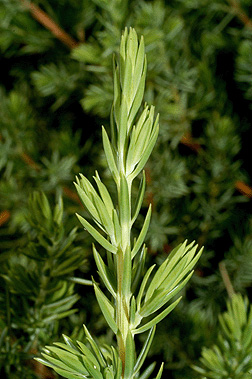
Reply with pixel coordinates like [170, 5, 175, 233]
[0, 192, 83, 378]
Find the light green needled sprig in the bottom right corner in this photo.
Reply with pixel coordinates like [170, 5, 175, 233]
[194, 294, 252, 379]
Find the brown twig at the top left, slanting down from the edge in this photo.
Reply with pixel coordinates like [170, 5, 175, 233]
[21, 0, 79, 49]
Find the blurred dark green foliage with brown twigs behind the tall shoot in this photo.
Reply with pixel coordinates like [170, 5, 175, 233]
[0, 0, 252, 379]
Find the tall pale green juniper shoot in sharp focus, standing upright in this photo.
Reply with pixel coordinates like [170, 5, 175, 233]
[38, 28, 202, 379]
